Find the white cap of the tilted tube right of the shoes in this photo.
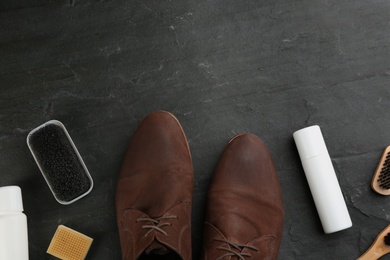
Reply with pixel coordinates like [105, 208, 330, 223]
[293, 125, 328, 160]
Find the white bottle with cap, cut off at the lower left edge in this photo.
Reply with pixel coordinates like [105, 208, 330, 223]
[0, 186, 28, 260]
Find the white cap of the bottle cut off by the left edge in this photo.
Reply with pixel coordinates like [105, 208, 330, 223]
[0, 186, 23, 212]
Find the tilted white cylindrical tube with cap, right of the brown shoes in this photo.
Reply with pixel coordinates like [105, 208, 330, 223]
[293, 125, 352, 234]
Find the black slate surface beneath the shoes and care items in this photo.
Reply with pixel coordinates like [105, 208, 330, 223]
[0, 0, 390, 259]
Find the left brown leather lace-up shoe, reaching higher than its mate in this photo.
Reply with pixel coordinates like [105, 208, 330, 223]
[116, 111, 193, 260]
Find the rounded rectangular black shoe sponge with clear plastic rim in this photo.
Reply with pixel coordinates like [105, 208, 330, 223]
[27, 120, 93, 205]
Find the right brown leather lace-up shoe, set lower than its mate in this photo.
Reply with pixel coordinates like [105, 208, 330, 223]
[203, 134, 284, 260]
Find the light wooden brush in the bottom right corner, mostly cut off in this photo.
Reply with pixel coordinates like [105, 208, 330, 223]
[357, 225, 390, 260]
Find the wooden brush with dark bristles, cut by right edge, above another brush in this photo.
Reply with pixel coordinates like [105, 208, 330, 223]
[371, 146, 390, 195]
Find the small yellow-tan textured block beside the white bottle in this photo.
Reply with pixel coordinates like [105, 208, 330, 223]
[47, 225, 93, 260]
